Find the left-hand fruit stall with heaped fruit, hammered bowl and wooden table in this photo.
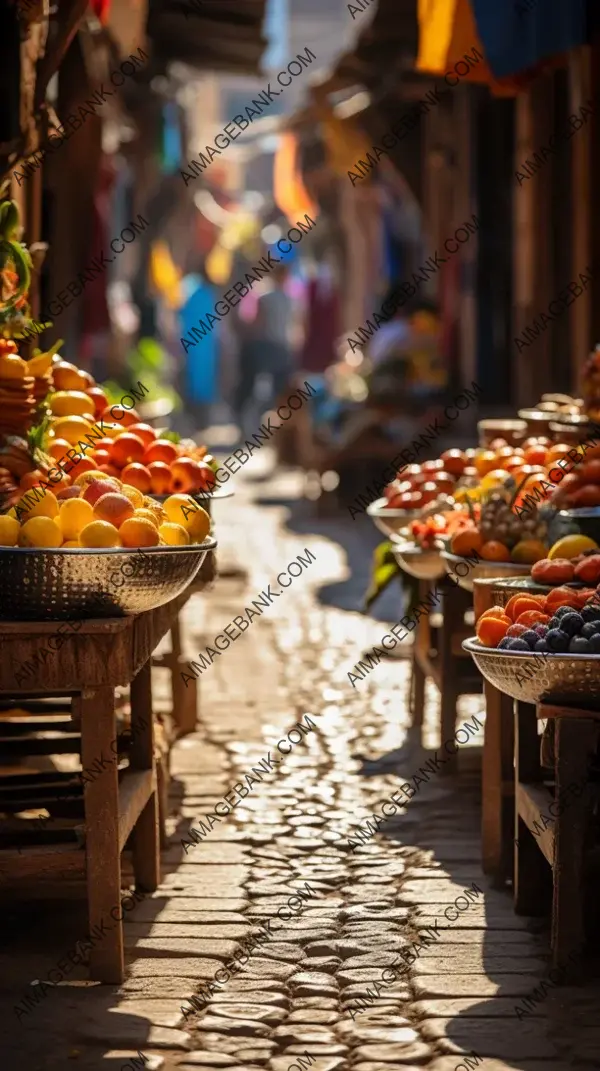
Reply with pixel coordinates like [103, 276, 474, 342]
[0, 192, 230, 982]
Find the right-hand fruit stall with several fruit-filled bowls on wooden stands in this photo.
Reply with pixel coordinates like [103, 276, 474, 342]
[368, 389, 600, 978]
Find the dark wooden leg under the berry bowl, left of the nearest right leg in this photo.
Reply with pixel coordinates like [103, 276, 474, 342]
[514, 699, 551, 916]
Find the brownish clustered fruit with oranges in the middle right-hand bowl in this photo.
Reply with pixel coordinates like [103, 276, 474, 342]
[450, 489, 548, 564]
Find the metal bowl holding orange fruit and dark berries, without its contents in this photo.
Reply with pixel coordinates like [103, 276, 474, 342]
[463, 638, 600, 713]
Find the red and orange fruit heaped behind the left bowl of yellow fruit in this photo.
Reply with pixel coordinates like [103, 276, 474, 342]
[0, 340, 218, 510]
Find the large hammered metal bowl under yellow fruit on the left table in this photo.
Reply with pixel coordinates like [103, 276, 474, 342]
[0, 539, 216, 621]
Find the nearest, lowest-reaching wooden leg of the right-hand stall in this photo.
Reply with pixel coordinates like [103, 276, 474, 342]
[552, 718, 598, 982]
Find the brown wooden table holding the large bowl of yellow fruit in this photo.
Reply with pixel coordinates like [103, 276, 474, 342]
[0, 591, 189, 982]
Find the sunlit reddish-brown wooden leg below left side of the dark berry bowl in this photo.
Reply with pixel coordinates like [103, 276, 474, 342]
[481, 681, 514, 888]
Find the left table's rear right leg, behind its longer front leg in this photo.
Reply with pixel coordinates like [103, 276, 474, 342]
[130, 659, 161, 892]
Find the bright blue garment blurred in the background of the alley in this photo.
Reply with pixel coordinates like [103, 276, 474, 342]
[179, 275, 221, 403]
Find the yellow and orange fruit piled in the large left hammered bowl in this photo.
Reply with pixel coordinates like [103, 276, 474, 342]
[0, 471, 210, 549]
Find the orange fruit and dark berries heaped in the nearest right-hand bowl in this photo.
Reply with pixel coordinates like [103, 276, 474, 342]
[476, 588, 600, 654]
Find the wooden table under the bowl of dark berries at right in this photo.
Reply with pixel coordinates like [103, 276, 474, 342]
[514, 702, 600, 982]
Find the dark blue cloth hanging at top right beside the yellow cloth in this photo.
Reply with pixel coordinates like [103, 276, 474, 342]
[471, 0, 587, 78]
